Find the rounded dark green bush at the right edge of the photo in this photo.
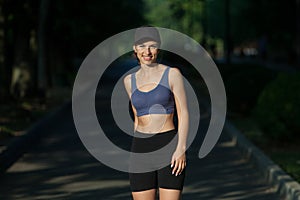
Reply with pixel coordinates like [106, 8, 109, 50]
[253, 72, 300, 140]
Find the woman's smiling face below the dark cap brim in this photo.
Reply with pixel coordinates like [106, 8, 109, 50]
[133, 41, 158, 65]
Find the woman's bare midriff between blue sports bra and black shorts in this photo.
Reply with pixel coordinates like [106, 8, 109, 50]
[136, 114, 175, 134]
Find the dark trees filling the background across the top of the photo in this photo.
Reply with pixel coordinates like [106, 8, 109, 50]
[0, 0, 300, 103]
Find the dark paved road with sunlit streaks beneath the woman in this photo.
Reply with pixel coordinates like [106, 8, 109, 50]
[0, 99, 280, 200]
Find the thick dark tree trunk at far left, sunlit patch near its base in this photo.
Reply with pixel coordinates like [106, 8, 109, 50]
[7, 0, 34, 99]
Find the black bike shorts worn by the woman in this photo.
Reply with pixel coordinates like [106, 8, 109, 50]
[129, 130, 185, 192]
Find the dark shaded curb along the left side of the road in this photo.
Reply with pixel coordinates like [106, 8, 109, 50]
[0, 102, 70, 176]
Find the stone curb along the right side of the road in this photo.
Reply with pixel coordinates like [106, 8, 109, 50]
[224, 120, 300, 200]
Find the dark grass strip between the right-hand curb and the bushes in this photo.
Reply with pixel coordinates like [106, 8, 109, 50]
[232, 117, 300, 182]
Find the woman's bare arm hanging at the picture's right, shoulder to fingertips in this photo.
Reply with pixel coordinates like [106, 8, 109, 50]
[169, 68, 189, 176]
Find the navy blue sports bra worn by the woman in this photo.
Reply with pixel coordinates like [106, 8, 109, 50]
[131, 67, 174, 117]
